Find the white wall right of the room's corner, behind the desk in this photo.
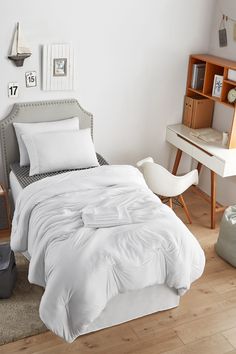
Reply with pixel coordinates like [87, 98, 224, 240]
[200, 0, 236, 205]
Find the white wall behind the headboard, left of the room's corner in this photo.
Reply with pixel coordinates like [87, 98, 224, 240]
[0, 0, 215, 183]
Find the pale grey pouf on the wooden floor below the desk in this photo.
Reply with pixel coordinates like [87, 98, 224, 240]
[215, 205, 236, 267]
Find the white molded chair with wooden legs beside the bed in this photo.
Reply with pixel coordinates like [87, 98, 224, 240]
[137, 157, 198, 224]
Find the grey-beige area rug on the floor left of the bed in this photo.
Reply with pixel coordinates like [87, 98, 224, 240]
[0, 254, 47, 345]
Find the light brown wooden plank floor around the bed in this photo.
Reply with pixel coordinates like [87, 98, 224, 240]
[0, 191, 236, 354]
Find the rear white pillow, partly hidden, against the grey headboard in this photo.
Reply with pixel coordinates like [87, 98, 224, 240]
[13, 117, 79, 166]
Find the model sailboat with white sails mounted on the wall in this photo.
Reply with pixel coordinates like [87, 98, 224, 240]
[8, 22, 32, 66]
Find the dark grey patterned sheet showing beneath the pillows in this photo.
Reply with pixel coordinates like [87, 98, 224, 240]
[11, 153, 108, 188]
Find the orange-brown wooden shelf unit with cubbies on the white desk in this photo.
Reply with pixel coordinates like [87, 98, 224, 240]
[186, 54, 236, 149]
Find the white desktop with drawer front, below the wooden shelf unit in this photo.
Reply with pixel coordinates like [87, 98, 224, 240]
[166, 124, 236, 177]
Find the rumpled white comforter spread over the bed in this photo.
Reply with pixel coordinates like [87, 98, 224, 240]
[11, 166, 205, 342]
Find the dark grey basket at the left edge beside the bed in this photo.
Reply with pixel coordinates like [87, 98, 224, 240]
[0, 244, 16, 299]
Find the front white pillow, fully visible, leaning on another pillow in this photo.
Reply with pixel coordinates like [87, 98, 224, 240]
[22, 129, 99, 176]
